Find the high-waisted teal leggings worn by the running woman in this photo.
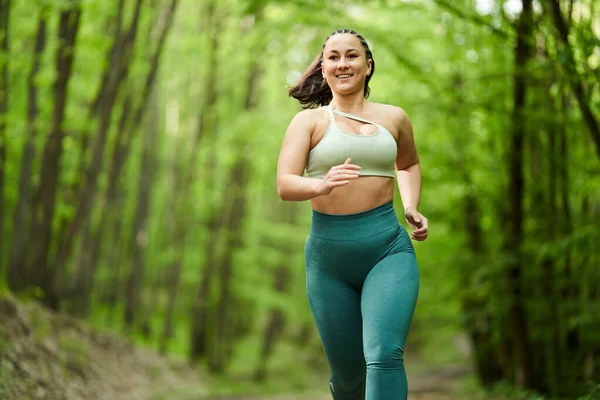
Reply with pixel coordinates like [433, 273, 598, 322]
[305, 202, 419, 400]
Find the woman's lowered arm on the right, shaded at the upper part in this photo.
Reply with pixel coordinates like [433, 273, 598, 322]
[396, 108, 428, 241]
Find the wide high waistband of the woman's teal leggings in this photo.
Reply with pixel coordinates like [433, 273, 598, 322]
[310, 201, 400, 241]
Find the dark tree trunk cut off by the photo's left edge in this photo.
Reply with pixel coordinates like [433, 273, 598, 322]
[0, 0, 11, 272]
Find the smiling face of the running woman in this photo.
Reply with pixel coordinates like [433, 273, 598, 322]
[321, 33, 373, 94]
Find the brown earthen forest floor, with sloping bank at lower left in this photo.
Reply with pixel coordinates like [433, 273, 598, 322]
[0, 295, 480, 400]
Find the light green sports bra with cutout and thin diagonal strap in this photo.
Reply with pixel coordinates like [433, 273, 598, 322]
[306, 106, 397, 178]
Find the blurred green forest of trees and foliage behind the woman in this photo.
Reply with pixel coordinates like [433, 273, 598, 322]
[0, 0, 600, 399]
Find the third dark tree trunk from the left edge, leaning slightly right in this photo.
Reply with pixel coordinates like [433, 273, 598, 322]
[29, 2, 81, 308]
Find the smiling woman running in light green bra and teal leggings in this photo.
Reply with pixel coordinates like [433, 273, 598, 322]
[277, 29, 428, 400]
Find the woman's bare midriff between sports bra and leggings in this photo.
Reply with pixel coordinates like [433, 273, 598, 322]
[311, 176, 395, 214]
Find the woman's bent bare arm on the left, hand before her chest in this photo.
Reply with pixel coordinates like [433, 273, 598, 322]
[277, 110, 359, 201]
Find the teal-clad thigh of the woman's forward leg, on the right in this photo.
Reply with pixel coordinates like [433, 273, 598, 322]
[361, 251, 419, 354]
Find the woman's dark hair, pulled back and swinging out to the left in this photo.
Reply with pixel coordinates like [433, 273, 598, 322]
[288, 29, 375, 108]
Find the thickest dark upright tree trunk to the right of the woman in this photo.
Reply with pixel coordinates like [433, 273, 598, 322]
[504, 0, 534, 388]
